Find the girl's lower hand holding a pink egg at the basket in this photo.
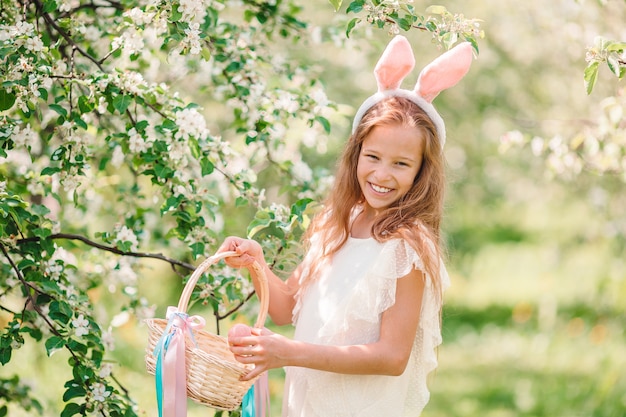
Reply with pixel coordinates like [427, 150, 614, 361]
[228, 327, 291, 381]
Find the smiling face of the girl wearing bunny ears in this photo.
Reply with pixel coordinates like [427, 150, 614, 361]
[357, 124, 424, 212]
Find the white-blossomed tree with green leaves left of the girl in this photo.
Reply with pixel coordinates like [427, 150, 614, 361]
[0, 0, 481, 417]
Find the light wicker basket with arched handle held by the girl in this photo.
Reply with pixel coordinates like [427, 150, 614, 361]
[145, 252, 269, 410]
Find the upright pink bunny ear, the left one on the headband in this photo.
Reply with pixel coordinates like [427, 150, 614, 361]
[374, 35, 415, 91]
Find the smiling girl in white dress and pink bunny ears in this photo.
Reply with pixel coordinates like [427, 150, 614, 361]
[220, 36, 472, 417]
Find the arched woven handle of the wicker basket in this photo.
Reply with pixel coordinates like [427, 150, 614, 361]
[178, 251, 270, 329]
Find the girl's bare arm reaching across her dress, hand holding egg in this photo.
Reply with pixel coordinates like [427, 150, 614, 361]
[229, 270, 424, 379]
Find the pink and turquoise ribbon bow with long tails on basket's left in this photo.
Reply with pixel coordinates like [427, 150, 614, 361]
[153, 307, 205, 417]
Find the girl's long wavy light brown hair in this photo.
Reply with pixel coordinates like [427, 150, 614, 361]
[302, 96, 445, 295]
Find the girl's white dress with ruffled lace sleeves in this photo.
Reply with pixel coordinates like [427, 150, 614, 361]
[283, 238, 450, 417]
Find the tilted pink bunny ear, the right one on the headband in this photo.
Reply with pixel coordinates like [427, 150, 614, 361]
[415, 42, 474, 103]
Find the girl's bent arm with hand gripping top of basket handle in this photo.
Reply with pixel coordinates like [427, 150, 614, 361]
[218, 236, 300, 326]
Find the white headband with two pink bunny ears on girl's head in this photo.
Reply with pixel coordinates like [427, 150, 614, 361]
[352, 35, 473, 148]
